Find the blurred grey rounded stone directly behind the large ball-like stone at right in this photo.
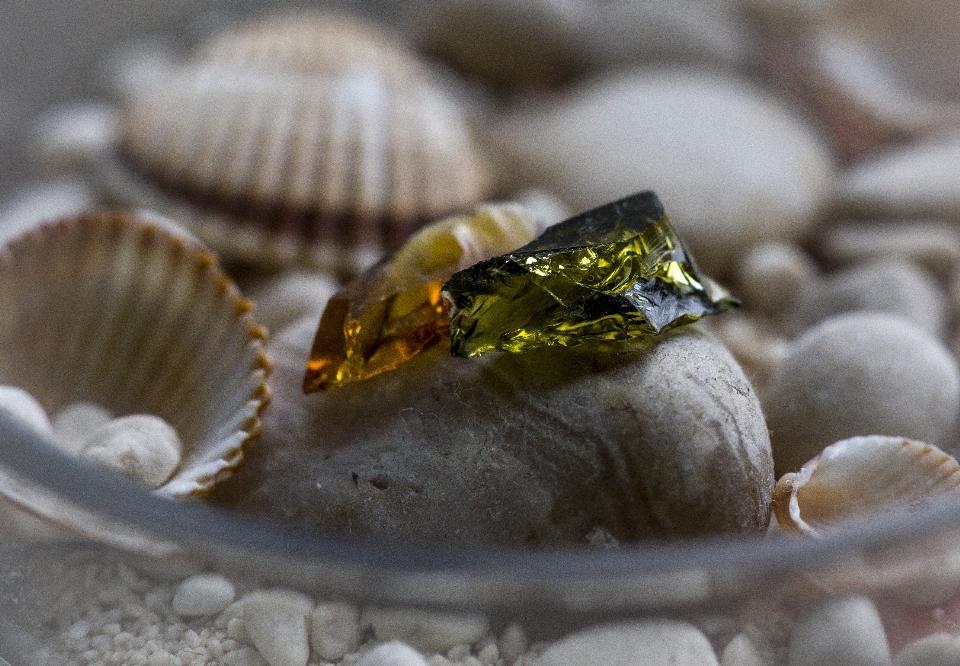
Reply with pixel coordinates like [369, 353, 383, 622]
[794, 261, 948, 338]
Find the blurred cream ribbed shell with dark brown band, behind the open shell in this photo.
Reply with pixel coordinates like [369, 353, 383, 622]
[101, 13, 490, 274]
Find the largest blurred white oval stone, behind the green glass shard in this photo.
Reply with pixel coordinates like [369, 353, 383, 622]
[491, 69, 834, 274]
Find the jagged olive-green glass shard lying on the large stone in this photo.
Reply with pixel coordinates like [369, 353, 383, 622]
[443, 192, 737, 357]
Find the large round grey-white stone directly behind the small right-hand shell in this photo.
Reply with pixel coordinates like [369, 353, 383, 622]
[764, 312, 960, 477]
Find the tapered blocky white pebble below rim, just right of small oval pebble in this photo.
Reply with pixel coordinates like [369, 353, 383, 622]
[243, 590, 313, 666]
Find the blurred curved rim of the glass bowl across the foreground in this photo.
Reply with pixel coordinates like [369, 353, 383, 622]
[0, 412, 960, 621]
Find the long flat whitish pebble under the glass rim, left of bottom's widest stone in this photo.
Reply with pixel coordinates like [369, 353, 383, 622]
[363, 609, 489, 653]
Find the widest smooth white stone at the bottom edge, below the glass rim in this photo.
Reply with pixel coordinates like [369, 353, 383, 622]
[533, 620, 717, 666]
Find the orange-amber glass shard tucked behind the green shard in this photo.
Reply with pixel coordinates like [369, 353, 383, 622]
[303, 204, 537, 393]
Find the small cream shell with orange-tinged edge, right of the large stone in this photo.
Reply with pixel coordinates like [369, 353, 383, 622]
[773, 435, 960, 535]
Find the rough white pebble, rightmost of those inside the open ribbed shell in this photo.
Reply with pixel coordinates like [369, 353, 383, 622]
[81, 414, 182, 488]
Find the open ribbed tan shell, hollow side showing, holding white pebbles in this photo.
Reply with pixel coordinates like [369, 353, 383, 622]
[0, 212, 270, 498]
